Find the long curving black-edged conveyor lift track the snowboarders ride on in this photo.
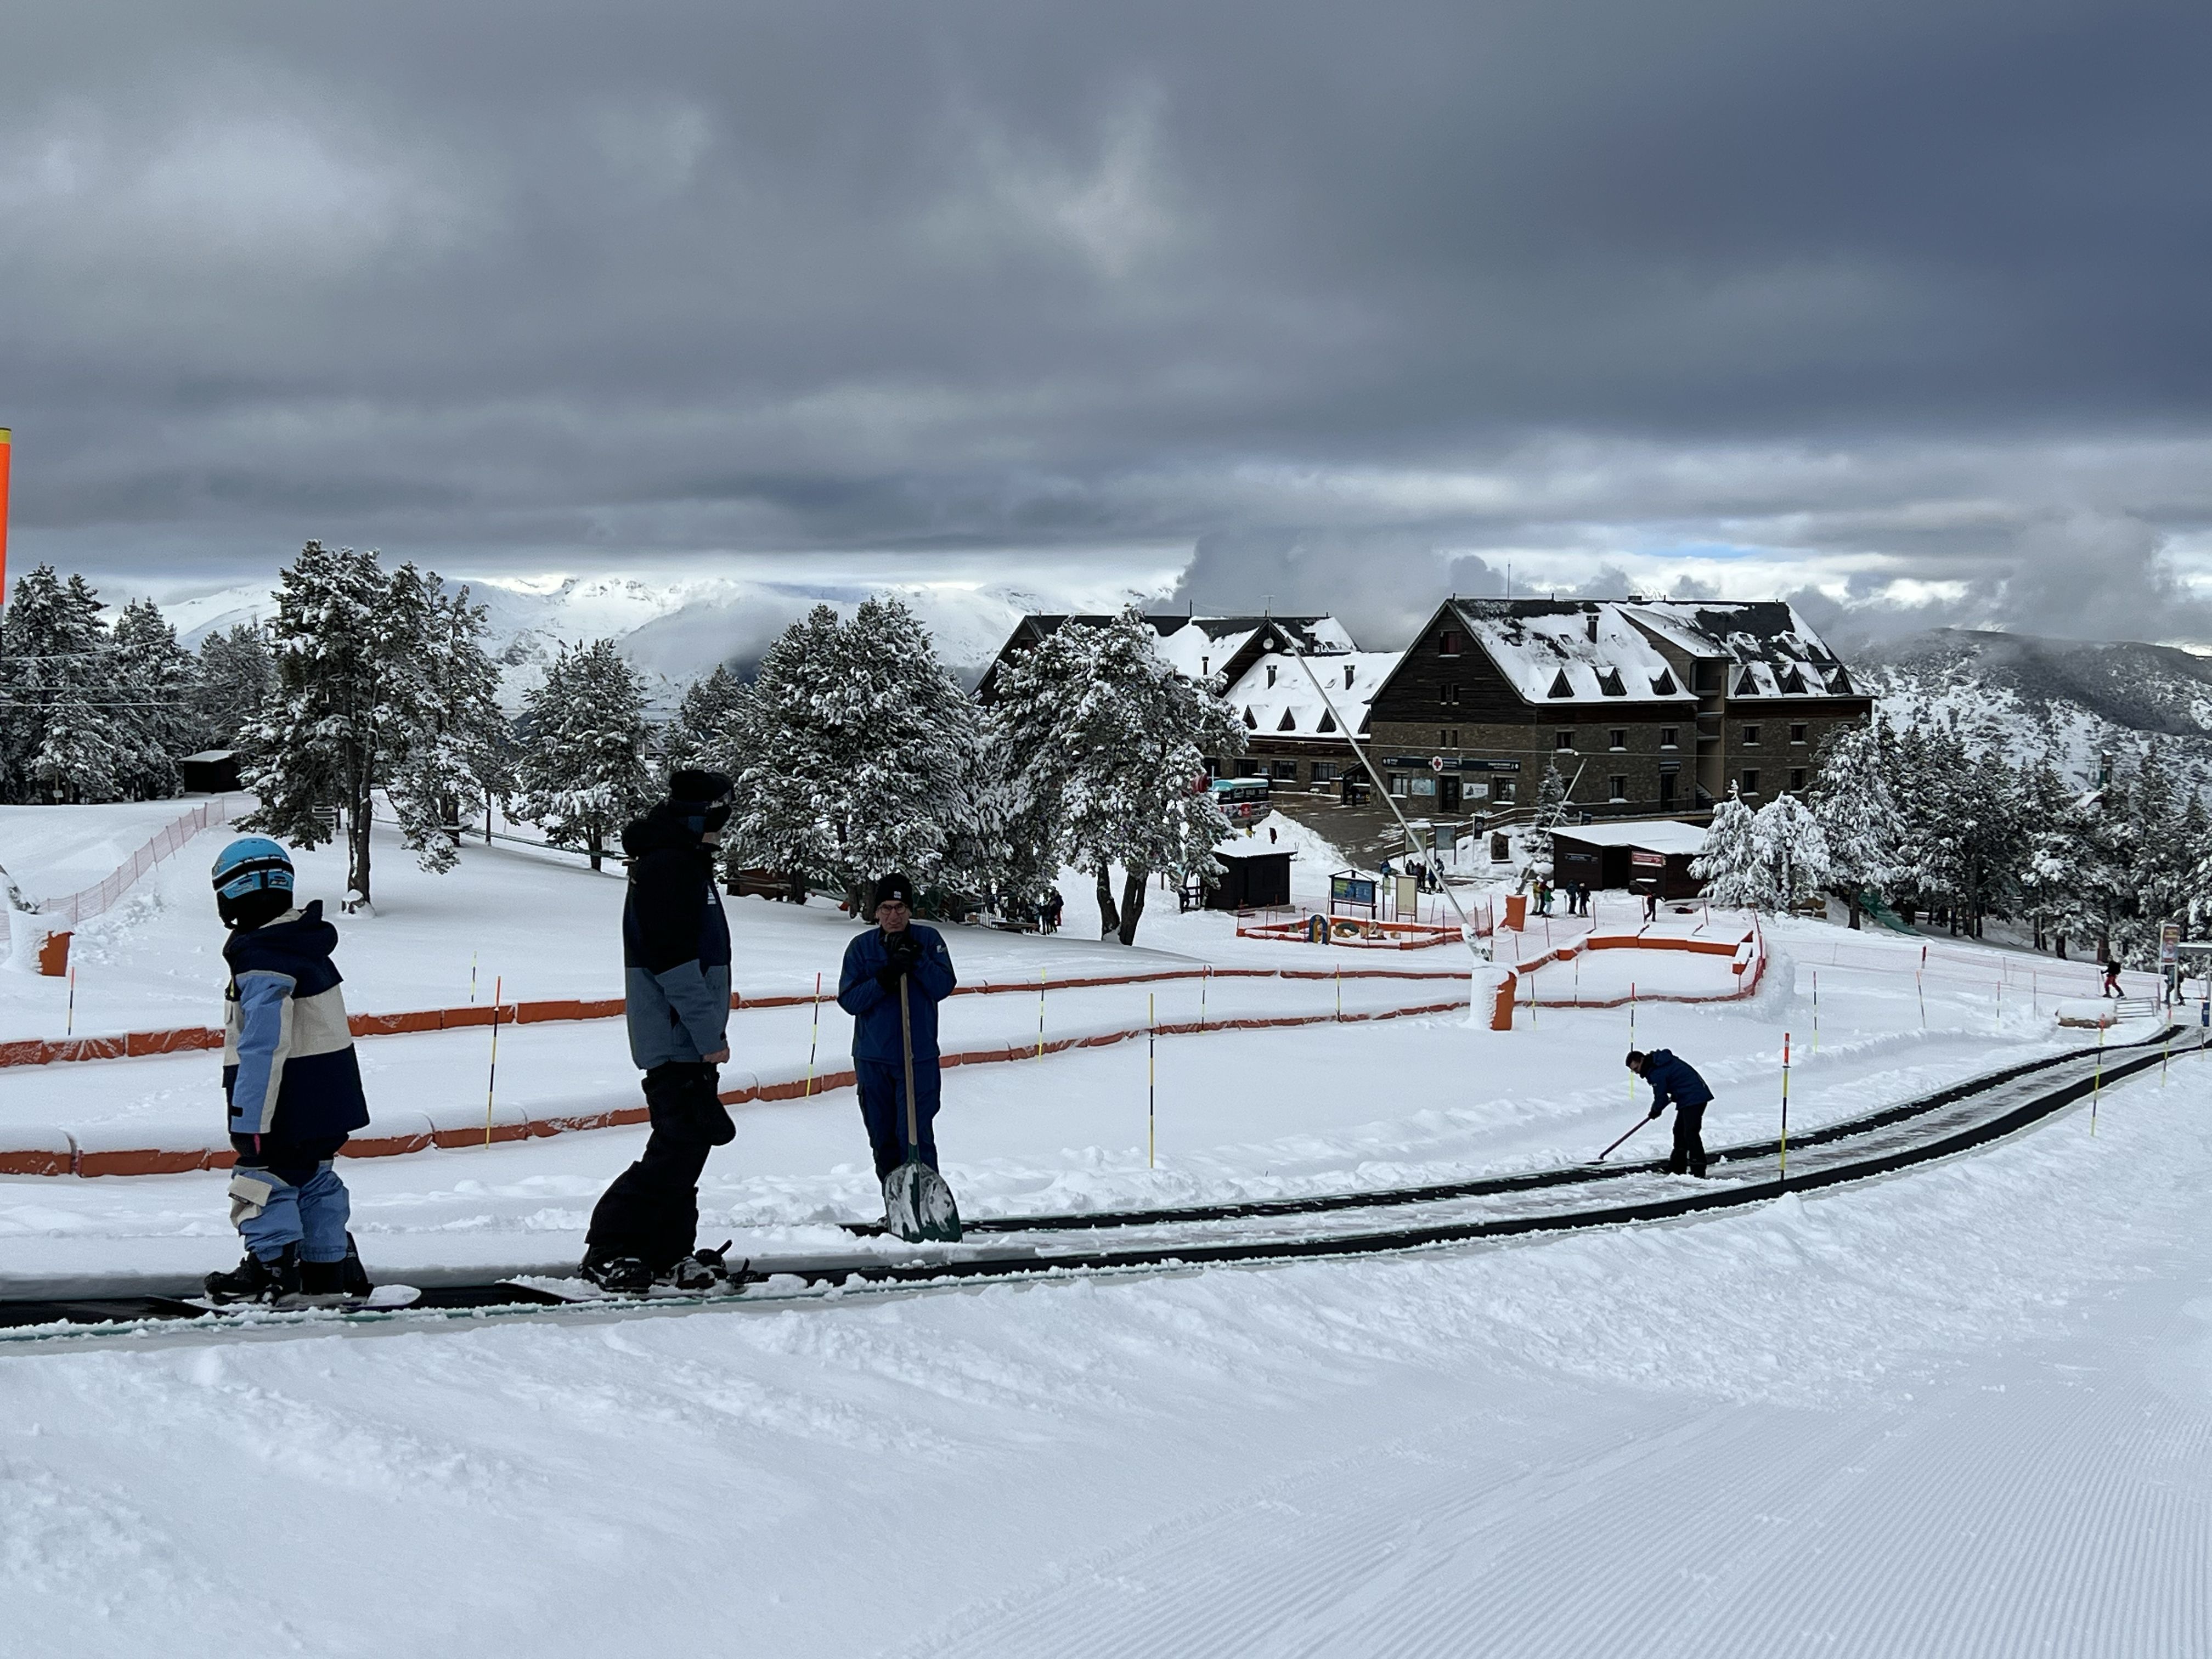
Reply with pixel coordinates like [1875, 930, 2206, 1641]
[0, 1026, 2201, 1347]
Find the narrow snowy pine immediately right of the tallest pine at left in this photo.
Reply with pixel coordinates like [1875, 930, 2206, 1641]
[385, 579, 511, 874]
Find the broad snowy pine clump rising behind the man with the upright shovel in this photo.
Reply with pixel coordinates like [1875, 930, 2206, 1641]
[728, 600, 984, 911]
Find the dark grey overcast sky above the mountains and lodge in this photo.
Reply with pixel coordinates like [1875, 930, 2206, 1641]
[0, 0, 2212, 646]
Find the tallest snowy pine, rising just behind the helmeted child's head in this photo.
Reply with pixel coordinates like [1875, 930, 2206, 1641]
[239, 542, 422, 907]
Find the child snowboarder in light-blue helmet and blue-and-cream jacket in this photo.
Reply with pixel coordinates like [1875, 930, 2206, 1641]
[206, 836, 369, 1301]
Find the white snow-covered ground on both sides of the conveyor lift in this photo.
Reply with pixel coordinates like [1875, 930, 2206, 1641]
[0, 800, 2212, 1659]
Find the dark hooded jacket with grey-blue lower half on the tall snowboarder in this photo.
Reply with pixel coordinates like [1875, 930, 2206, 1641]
[622, 801, 730, 1070]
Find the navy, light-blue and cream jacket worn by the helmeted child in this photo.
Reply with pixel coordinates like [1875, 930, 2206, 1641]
[223, 900, 369, 1146]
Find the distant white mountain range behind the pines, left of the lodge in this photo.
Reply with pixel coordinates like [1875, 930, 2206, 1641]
[163, 575, 1148, 708]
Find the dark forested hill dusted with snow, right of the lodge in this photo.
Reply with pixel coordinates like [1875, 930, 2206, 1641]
[1852, 628, 2212, 789]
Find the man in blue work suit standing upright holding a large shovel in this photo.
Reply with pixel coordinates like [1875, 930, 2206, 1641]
[836, 876, 956, 1181]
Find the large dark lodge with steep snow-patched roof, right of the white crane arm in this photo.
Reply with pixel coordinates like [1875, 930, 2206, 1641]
[1367, 597, 1874, 819]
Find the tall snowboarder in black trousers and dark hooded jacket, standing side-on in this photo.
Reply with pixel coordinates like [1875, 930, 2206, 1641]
[582, 768, 737, 1294]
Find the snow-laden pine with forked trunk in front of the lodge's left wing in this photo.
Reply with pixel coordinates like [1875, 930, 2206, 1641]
[993, 611, 1245, 945]
